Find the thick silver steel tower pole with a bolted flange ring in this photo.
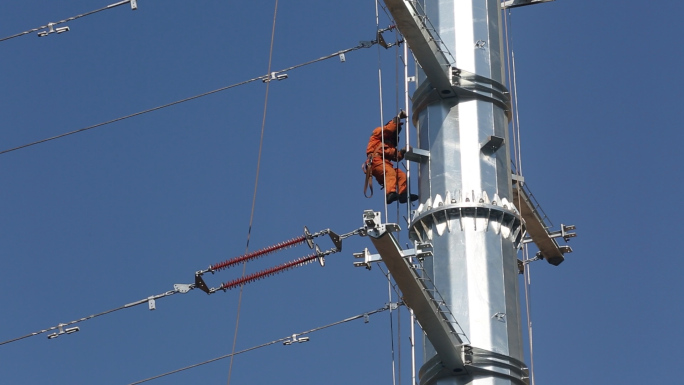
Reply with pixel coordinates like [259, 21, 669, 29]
[385, 0, 527, 385]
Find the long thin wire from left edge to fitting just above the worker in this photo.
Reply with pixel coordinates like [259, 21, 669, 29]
[0, 42, 370, 155]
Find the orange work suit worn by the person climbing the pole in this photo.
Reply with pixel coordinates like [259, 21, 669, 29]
[366, 119, 406, 195]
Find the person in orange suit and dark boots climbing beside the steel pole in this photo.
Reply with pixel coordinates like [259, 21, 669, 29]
[363, 110, 418, 204]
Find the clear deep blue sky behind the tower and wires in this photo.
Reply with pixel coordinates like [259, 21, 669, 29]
[0, 0, 684, 385]
